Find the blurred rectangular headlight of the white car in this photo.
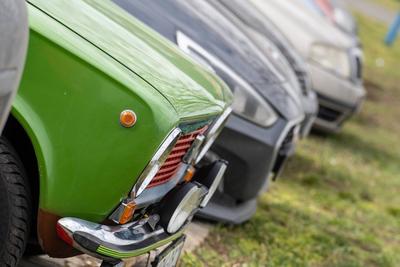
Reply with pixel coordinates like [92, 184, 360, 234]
[310, 44, 351, 78]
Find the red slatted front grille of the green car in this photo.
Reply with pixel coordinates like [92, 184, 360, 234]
[147, 126, 208, 188]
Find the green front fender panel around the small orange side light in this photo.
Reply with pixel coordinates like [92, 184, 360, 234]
[12, 7, 179, 221]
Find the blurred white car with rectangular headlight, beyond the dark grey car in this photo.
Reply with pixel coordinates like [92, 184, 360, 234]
[251, 0, 366, 132]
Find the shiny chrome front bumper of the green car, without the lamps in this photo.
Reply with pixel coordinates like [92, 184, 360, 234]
[57, 215, 183, 261]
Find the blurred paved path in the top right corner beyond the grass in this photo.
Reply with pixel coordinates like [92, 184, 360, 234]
[339, 0, 397, 25]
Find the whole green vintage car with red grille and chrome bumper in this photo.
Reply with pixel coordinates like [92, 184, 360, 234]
[0, 0, 232, 266]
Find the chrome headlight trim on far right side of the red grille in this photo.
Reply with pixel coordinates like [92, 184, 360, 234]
[195, 107, 232, 164]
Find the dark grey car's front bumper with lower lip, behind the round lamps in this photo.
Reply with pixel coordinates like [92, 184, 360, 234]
[197, 115, 300, 224]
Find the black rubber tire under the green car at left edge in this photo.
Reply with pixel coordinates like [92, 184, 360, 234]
[0, 137, 32, 267]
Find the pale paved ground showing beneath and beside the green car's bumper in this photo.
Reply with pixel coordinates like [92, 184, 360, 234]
[19, 223, 211, 267]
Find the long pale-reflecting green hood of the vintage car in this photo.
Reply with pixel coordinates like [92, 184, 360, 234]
[28, 0, 232, 120]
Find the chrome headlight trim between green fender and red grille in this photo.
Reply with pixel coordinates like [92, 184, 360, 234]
[131, 128, 182, 198]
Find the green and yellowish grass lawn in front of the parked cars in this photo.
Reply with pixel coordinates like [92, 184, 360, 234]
[183, 8, 400, 267]
